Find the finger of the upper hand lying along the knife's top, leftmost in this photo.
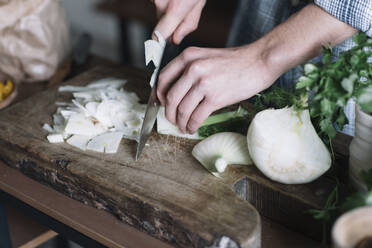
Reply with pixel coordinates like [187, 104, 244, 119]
[154, 1, 196, 39]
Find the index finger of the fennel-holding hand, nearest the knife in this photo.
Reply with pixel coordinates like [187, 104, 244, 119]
[157, 47, 205, 106]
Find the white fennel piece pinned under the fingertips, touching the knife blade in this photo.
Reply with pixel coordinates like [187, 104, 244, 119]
[156, 107, 201, 139]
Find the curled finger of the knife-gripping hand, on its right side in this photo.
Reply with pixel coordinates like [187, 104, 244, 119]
[172, 1, 205, 44]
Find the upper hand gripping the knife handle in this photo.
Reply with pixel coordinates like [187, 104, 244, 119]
[152, 0, 206, 44]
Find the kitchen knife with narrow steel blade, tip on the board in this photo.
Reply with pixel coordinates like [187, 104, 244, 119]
[136, 43, 179, 161]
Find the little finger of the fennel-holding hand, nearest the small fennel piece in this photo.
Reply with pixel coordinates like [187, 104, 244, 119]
[186, 98, 215, 133]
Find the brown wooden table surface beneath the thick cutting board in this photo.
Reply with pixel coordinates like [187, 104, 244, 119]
[0, 63, 316, 247]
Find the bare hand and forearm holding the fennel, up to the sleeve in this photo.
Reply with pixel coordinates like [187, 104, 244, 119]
[157, 3, 357, 133]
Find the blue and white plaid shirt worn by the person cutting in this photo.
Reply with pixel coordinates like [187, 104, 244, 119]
[227, 0, 372, 135]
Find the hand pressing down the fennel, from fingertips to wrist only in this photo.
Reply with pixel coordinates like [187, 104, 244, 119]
[157, 44, 278, 133]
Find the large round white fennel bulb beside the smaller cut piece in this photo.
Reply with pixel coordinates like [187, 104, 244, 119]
[247, 108, 332, 184]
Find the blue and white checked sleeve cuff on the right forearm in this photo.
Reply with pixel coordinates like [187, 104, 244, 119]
[314, 0, 372, 37]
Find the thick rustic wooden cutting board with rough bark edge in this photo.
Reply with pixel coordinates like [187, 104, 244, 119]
[0, 67, 349, 247]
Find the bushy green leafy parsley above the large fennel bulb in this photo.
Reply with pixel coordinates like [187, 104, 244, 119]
[296, 33, 372, 139]
